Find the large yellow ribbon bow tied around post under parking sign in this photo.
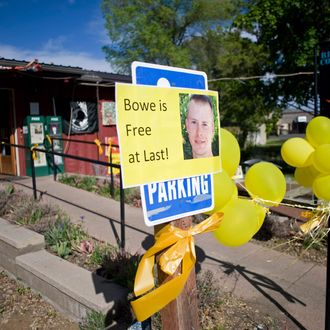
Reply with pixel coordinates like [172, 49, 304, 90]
[131, 212, 223, 321]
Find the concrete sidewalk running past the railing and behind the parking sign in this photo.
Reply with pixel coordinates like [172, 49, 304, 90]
[0, 176, 326, 330]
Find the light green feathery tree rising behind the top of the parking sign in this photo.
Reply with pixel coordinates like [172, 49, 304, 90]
[101, 0, 236, 73]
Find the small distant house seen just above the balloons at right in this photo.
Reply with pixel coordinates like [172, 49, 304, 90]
[277, 109, 314, 135]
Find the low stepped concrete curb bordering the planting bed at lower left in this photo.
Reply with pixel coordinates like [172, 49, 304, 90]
[0, 218, 127, 321]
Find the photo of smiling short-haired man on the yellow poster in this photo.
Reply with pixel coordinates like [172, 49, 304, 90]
[181, 94, 219, 159]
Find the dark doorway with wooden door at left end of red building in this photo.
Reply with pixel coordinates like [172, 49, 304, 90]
[0, 89, 16, 175]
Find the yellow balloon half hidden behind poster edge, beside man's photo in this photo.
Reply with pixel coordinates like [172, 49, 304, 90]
[220, 128, 241, 177]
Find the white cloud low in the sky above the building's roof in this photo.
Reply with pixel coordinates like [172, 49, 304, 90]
[0, 40, 114, 73]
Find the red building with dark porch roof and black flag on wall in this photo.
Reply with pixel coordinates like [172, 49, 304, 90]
[0, 58, 131, 175]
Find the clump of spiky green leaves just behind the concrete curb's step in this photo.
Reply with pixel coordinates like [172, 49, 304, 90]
[45, 218, 87, 258]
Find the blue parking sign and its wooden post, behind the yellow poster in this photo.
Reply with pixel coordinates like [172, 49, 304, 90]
[132, 62, 214, 330]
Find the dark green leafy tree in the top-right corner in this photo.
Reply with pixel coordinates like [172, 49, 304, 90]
[235, 0, 330, 104]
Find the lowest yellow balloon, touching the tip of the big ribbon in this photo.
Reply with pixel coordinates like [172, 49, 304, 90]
[214, 199, 258, 246]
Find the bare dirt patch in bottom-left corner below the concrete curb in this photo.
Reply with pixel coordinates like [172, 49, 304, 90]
[0, 272, 79, 330]
